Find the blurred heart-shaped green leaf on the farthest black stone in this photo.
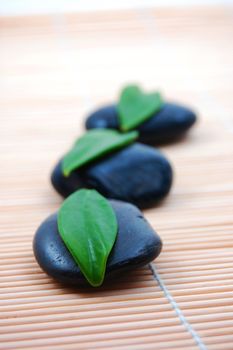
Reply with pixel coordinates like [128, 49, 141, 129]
[117, 85, 163, 131]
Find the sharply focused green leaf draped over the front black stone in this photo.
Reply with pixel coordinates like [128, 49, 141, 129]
[58, 189, 118, 287]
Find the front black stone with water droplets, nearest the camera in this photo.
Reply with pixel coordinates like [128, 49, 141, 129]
[33, 200, 162, 286]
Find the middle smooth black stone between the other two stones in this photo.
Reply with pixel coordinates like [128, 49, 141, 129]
[51, 143, 172, 208]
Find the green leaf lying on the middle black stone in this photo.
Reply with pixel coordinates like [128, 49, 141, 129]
[62, 129, 138, 176]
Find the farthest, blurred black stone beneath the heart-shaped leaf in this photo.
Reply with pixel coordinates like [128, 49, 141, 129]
[86, 103, 197, 145]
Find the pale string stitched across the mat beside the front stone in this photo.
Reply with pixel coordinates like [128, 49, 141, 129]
[149, 263, 207, 350]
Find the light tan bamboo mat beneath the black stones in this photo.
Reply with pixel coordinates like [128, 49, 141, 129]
[0, 7, 233, 350]
